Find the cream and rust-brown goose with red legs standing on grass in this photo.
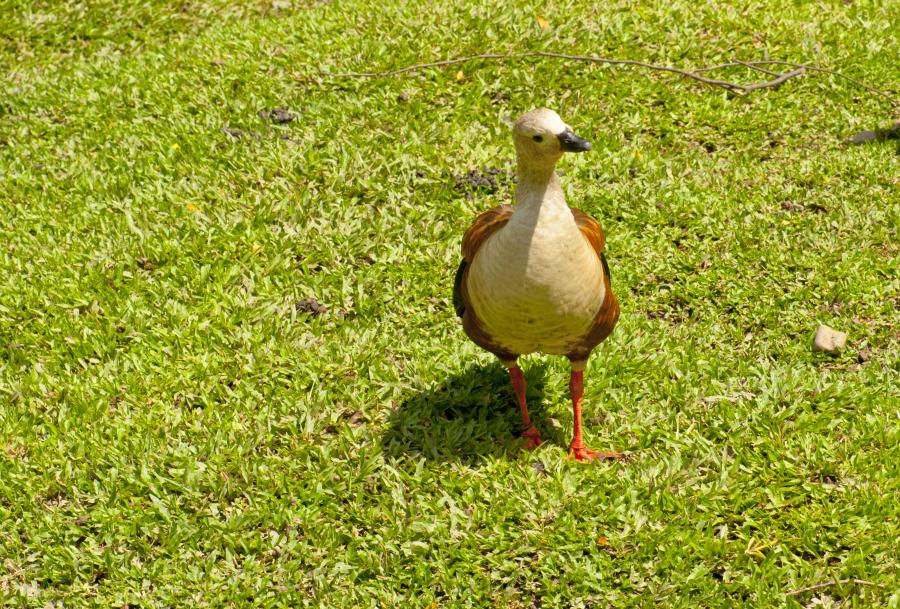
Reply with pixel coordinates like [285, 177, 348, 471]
[453, 108, 621, 461]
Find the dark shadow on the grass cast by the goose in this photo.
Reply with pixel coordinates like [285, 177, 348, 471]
[381, 363, 560, 465]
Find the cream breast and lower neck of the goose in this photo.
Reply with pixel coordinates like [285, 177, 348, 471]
[468, 174, 606, 355]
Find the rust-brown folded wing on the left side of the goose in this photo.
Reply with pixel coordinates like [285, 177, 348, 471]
[453, 205, 518, 361]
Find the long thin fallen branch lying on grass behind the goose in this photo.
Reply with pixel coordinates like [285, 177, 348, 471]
[322, 51, 900, 106]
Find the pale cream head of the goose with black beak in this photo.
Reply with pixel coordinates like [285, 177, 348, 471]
[513, 108, 591, 165]
